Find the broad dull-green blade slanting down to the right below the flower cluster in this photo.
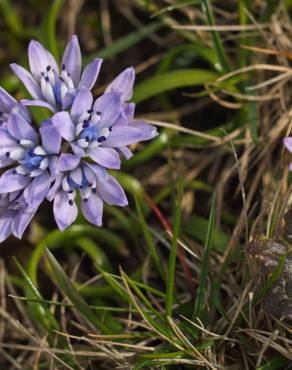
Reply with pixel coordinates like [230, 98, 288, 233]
[46, 249, 108, 333]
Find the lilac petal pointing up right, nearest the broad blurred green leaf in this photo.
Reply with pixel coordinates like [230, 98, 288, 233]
[105, 67, 135, 101]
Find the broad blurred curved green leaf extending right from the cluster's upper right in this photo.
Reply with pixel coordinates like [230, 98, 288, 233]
[133, 69, 218, 103]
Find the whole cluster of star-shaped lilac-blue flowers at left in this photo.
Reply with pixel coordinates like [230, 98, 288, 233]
[0, 35, 157, 241]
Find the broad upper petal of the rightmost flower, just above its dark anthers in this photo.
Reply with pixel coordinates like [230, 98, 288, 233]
[93, 92, 121, 127]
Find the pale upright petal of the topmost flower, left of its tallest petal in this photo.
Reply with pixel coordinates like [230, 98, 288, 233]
[28, 40, 59, 79]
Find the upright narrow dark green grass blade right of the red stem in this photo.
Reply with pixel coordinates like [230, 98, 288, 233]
[193, 194, 216, 319]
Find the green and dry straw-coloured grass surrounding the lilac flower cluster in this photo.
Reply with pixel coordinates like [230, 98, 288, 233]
[0, 0, 292, 370]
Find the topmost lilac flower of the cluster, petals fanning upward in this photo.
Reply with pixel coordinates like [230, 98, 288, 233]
[10, 35, 102, 112]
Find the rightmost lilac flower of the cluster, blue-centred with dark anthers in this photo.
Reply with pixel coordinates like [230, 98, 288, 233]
[52, 68, 157, 169]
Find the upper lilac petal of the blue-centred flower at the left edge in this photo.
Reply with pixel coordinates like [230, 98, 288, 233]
[7, 113, 38, 143]
